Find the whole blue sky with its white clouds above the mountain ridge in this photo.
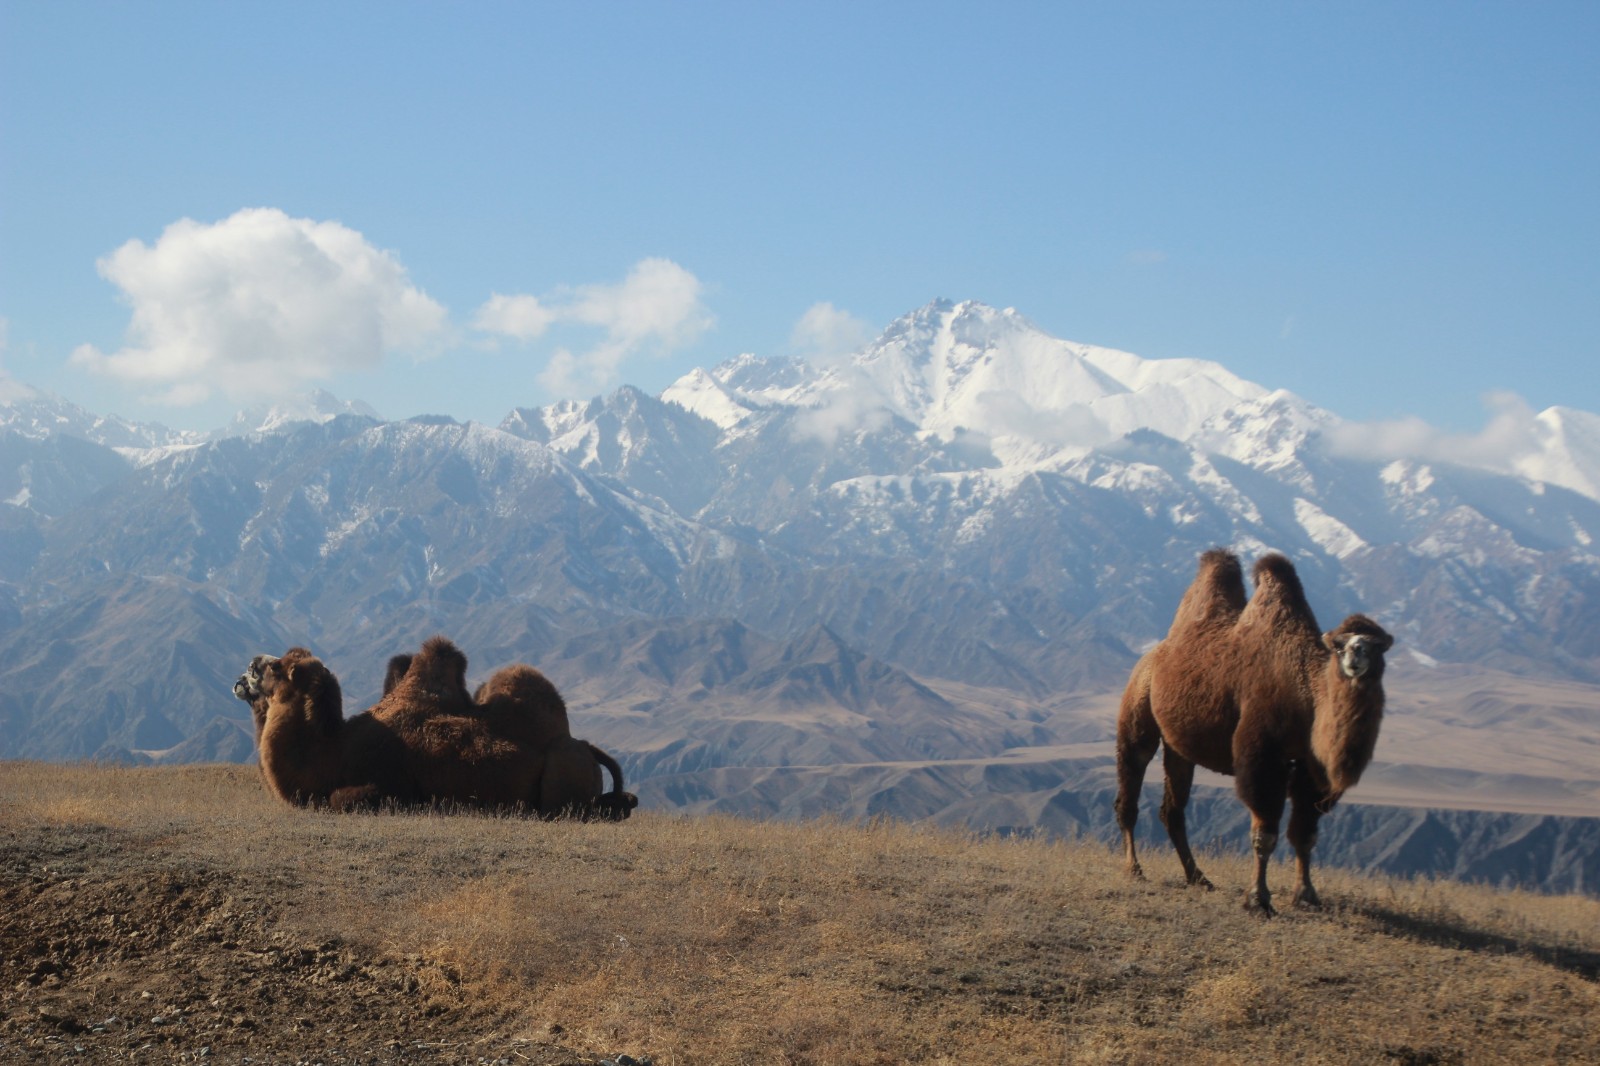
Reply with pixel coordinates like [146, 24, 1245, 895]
[0, 0, 1600, 431]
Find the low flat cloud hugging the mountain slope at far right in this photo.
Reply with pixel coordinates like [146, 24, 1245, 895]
[1328, 392, 1542, 472]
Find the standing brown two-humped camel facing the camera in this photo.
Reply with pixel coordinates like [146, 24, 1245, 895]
[1117, 549, 1394, 914]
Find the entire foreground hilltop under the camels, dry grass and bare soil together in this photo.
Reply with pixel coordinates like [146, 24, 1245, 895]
[0, 762, 1600, 1066]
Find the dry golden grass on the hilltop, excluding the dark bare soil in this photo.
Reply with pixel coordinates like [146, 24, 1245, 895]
[0, 763, 1600, 1066]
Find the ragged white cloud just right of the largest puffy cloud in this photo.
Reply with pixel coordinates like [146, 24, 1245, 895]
[472, 259, 712, 395]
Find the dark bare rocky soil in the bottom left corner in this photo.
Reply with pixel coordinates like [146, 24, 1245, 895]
[0, 829, 627, 1066]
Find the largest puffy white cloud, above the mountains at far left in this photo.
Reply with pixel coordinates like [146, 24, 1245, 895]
[72, 208, 446, 405]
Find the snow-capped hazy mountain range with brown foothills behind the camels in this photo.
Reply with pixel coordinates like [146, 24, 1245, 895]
[0, 301, 1600, 877]
